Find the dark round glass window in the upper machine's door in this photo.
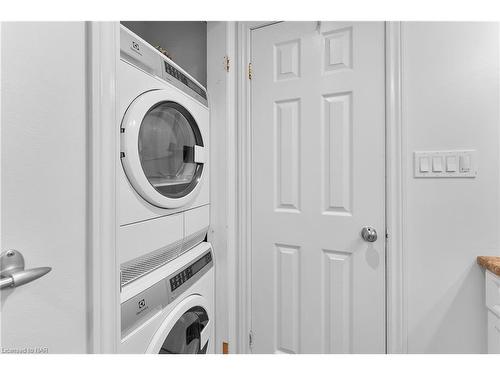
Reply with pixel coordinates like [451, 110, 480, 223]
[138, 101, 203, 199]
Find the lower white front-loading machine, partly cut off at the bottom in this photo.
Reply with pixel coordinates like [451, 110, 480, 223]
[119, 242, 215, 354]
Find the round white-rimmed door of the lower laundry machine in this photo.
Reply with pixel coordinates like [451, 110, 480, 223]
[147, 295, 211, 354]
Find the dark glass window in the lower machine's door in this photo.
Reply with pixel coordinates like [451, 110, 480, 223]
[159, 306, 208, 354]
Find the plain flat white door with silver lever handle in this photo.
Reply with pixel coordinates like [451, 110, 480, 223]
[0, 22, 90, 353]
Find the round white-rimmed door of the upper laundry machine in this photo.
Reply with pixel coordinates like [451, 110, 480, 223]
[121, 90, 205, 208]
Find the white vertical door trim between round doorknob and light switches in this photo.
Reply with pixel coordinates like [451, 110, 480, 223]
[385, 22, 408, 354]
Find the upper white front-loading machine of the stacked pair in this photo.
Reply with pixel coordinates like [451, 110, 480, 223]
[117, 26, 210, 286]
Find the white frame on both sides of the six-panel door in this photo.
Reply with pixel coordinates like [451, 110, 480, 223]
[229, 22, 407, 353]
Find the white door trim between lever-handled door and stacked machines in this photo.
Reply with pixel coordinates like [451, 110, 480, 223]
[86, 22, 120, 353]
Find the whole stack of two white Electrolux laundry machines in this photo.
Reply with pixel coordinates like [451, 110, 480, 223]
[117, 26, 215, 353]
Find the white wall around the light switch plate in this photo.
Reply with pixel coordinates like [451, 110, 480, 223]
[402, 22, 500, 353]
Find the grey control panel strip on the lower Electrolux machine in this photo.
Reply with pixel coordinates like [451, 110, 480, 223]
[121, 250, 213, 339]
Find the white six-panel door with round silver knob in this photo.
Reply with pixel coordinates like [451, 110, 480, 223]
[251, 22, 385, 353]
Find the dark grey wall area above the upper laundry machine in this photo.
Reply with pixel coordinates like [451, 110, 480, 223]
[121, 21, 207, 86]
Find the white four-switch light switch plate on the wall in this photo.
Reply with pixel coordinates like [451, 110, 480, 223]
[413, 150, 477, 178]
